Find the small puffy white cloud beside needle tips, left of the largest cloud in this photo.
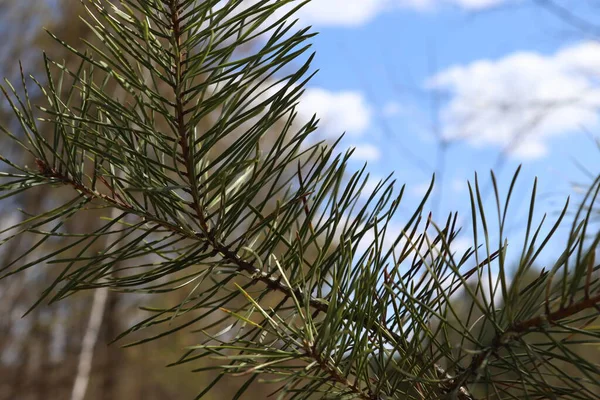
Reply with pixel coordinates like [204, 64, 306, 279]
[298, 88, 373, 137]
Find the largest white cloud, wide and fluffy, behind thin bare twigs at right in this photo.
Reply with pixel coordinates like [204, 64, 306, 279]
[427, 42, 600, 159]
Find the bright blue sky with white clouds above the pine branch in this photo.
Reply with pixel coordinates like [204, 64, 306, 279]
[284, 0, 600, 272]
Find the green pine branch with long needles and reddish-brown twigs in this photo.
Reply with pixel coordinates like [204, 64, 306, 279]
[0, 0, 600, 399]
